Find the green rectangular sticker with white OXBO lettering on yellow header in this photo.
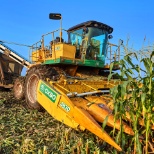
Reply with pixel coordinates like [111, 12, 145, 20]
[39, 82, 57, 103]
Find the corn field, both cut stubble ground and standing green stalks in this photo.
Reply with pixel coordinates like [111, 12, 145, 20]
[0, 44, 154, 154]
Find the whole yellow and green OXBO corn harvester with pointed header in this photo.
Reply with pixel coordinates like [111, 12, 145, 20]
[14, 13, 134, 151]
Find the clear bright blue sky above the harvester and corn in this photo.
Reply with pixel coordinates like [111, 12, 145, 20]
[0, 0, 154, 74]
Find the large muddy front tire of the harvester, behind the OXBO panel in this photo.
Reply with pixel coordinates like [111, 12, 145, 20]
[25, 65, 58, 111]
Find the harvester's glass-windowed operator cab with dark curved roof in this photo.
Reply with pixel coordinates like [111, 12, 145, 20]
[68, 21, 113, 63]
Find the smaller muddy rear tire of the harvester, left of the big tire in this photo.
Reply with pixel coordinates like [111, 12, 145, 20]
[13, 76, 25, 100]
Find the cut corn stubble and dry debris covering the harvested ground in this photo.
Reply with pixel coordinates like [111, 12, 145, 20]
[0, 91, 112, 154]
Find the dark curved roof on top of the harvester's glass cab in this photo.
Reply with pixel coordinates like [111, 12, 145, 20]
[67, 20, 113, 34]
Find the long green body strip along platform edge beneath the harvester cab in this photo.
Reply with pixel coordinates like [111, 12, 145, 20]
[43, 57, 104, 68]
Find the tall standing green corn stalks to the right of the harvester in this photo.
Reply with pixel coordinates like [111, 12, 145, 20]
[108, 51, 154, 154]
